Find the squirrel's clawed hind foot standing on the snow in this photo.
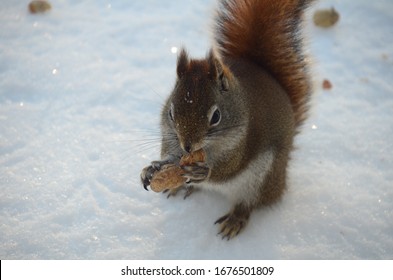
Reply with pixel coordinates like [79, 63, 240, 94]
[215, 203, 252, 240]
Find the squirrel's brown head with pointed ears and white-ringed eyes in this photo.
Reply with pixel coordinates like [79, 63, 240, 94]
[163, 47, 232, 153]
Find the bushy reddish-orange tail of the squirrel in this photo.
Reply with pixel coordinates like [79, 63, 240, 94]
[215, 0, 312, 124]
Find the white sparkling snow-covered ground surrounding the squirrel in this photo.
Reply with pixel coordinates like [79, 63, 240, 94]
[0, 0, 393, 259]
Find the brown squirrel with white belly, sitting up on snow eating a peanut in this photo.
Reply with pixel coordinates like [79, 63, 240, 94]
[141, 0, 312, 240]
